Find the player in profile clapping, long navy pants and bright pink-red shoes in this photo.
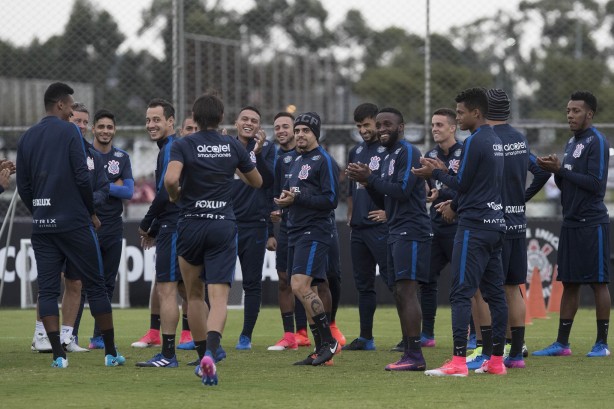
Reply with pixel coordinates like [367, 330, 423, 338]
[412, 88, 507, 376]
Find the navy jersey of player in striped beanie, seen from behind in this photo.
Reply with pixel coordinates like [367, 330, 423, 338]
[493, 124, 550, 238]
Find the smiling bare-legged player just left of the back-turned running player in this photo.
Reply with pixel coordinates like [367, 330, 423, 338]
[136, 98, 181, 368]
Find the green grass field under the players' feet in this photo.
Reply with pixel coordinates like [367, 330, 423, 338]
[0, 308, 614, 409]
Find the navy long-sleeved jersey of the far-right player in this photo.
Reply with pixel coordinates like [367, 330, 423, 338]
[554, 127, 610, 227]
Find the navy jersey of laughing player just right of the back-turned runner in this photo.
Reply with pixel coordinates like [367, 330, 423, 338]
[232, 138, 275, 226]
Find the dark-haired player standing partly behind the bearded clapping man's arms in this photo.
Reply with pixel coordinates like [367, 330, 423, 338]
[342, 103, 389, 351]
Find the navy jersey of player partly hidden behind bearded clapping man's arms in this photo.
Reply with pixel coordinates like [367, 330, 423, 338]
[348, 141, 387, 229]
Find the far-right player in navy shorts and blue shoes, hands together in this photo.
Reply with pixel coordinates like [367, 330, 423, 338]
[533, 91, 611, 357]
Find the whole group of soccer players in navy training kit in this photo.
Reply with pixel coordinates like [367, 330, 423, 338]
[18, 83, 610, 385]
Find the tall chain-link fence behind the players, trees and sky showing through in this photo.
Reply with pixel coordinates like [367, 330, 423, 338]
[0, 0, 614, 217]
